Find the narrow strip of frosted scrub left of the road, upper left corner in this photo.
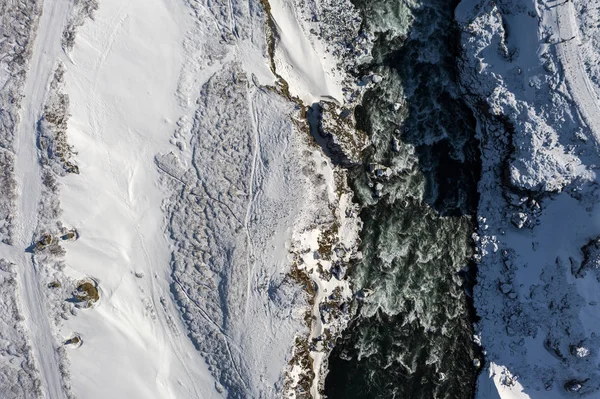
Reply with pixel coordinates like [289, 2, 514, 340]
[0, 0, 41, 244]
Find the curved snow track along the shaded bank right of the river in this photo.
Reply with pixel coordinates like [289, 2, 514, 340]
[552, 1, 600, 145]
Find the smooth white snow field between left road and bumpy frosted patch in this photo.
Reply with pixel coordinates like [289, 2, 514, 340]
[60, 0, 218, 398]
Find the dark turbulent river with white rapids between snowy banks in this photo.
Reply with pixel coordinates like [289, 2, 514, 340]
[325, 0, 480, 399]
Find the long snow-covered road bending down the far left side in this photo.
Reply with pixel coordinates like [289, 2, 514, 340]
[10, 0, 71, 399]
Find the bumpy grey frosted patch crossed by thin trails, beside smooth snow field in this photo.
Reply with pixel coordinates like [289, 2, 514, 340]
[162, 64, 310, 397]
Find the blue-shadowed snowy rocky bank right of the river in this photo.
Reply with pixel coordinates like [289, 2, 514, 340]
[456, 0, 600, 398]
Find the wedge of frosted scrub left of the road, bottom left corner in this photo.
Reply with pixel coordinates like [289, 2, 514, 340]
[0, 259, 42, 399]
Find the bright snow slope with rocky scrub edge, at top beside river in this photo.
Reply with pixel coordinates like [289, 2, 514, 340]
[268, 0, 369, 106]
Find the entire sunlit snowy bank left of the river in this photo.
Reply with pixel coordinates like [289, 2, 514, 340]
[0, 0, 366, 399]
